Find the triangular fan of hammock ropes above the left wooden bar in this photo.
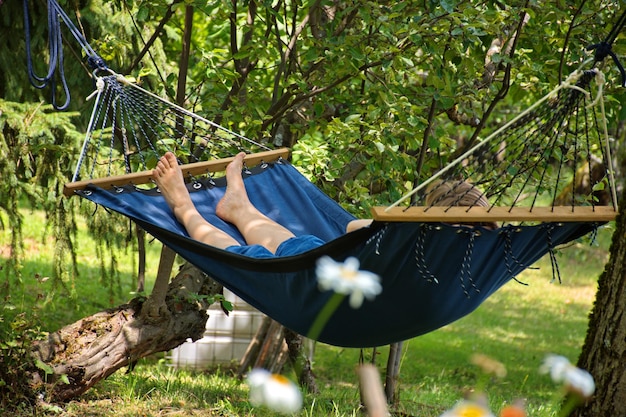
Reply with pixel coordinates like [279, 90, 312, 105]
[72, 70, 271, 188]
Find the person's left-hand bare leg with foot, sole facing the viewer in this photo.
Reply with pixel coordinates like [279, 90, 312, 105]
[152, 152, 239, 249]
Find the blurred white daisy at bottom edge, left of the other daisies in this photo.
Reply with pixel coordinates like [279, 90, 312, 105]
[247, 368, 302, 414]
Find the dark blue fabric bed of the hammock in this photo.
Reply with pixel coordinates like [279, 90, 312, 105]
[77, 162, 596, 347]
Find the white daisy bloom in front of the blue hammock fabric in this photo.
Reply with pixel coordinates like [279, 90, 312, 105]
[315, 256, 383, 308]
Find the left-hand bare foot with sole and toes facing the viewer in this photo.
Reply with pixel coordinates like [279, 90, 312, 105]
[152, 152, 194, 221]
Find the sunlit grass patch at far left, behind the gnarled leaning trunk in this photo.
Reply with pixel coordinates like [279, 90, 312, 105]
[0, 210, 154, 324]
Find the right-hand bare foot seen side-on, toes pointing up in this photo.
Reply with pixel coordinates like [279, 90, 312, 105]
[215, 152, 252, 223]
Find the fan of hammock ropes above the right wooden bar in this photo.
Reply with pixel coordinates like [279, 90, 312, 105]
[386, 69, 617, 221]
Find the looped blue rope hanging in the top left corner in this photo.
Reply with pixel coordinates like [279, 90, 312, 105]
[23, 0, 107, 110]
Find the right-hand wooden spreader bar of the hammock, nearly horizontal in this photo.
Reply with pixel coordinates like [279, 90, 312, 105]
[371, 206, 617, 223]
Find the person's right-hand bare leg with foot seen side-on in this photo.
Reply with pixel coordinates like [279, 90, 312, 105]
[215, 152, 294, 253]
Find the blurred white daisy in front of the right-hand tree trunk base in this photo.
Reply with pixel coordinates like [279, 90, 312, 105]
[539, 354, 596, 398]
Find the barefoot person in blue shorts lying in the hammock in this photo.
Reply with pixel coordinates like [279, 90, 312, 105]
[152, 152, 497, 258]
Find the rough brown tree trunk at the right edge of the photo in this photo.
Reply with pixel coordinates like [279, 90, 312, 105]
[574, 190, 626, 417]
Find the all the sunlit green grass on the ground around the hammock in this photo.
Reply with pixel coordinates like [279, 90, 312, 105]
[0, 206, 612, 417]
